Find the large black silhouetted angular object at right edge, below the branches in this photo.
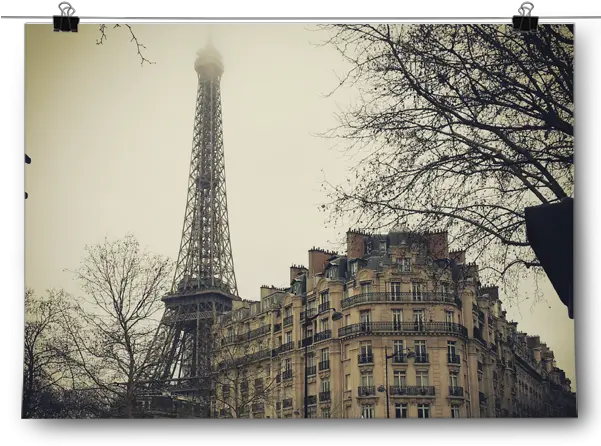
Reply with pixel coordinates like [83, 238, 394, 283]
[525, 198, 574, 319]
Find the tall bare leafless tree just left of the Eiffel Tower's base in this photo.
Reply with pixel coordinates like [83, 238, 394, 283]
[61, 235, 172, 418]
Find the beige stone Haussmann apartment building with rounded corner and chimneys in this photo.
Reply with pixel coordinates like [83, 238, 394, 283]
[212, 231, 576, 418]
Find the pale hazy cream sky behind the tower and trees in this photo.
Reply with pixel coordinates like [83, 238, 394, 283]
[25, 24, 575, 388]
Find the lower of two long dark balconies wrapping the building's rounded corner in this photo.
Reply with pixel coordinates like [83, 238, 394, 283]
[338, 322, 467, 338]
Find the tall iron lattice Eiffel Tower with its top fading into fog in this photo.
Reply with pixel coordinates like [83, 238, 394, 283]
[146, 40, 240, 418]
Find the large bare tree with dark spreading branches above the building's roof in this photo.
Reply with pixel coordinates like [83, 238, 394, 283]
[322, 25, 574, 296]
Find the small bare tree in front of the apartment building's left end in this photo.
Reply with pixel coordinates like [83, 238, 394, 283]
[213, 322, 281, 418]
